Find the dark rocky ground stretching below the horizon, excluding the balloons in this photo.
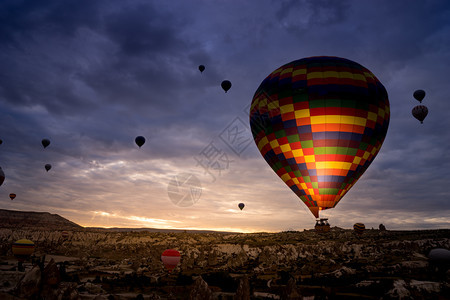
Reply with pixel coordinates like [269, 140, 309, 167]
[0, 228, 450, 299]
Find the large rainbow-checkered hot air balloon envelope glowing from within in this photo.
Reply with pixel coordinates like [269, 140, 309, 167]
[250, 56, 390, 218]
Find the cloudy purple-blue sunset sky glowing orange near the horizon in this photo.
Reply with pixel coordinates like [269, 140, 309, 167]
[0, 0, 450, 232]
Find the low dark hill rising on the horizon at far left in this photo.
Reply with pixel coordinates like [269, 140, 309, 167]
[0, 209, 83, 230]
